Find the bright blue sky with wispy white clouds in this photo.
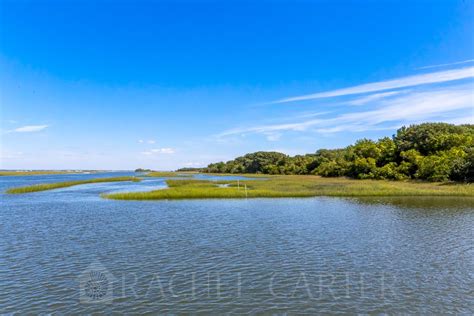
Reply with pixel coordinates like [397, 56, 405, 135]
[0, 0, 474, 170]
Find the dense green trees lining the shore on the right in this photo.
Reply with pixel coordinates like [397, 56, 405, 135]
[204, 123, 474, 182]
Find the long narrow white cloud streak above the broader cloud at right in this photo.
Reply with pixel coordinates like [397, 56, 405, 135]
[271, 67, 474, 103]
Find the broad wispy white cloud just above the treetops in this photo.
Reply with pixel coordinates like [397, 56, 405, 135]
[218, 84, 474, 137]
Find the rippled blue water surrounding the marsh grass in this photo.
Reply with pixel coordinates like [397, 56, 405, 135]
[0, 173, 474, 314]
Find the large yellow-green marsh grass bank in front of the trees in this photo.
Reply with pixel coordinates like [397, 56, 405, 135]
[102, 176, 474, 200]
